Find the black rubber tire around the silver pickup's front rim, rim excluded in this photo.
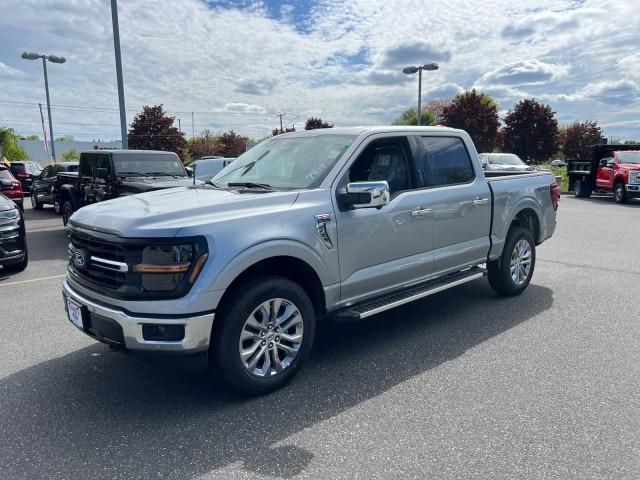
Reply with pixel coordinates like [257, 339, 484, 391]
[209, 275, 316, 395]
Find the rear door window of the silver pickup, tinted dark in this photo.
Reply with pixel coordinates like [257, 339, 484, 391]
[417, 137, 475, 187]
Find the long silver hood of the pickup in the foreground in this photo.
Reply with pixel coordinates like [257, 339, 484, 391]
[70, 186, 298, 237]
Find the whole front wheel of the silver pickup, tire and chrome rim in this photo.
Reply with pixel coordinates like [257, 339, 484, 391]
[209, 276, 315, 395]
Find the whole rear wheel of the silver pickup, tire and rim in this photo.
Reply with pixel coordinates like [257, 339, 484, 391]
[487, 227, 536, 296]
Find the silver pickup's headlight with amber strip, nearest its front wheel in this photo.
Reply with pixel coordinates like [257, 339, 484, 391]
[133, 245, 208, 292]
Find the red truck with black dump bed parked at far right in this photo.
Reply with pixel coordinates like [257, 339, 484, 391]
[567, 145, 640, 203]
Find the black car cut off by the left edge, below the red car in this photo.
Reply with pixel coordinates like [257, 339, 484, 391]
[0, 193, 29, 273]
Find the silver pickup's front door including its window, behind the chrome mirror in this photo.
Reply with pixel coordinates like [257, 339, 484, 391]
[336, 136, 433, 303]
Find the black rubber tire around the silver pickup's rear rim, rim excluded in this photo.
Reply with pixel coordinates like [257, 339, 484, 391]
[487, 227, 536, 296]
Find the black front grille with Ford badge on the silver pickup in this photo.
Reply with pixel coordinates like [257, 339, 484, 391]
[69, 229, 140, 290]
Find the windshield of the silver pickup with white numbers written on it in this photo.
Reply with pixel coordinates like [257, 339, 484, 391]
[211, 135, 356, 190]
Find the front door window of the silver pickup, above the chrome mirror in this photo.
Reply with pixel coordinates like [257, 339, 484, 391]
[349, 140, 412, 195]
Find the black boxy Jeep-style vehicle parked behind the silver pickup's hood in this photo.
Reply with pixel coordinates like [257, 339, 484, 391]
[52, 150, 199, 225]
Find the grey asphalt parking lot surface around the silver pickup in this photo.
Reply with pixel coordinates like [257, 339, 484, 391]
[0, 196, 640, 479]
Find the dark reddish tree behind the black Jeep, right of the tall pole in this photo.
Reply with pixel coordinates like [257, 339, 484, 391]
[128, 105, 187, 158]
